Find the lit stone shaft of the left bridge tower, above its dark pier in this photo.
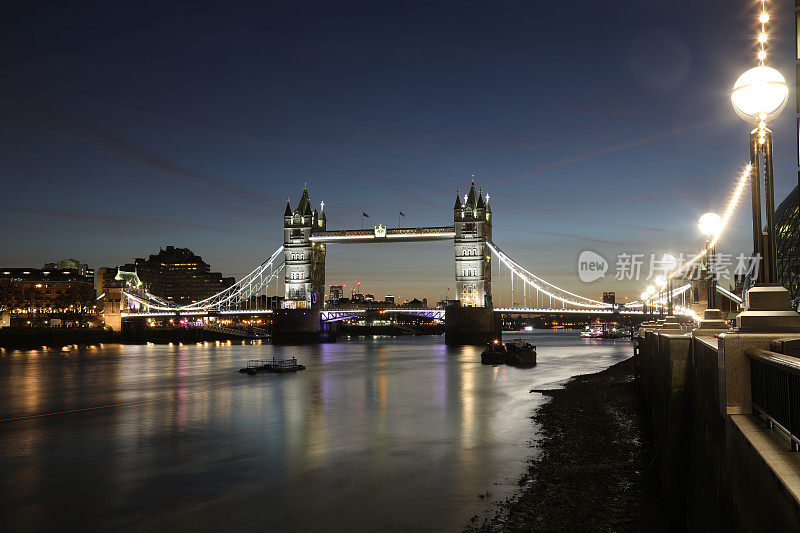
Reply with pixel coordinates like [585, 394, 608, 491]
[283, 187, 327, 309]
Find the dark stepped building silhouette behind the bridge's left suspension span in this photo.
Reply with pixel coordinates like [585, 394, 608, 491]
[120, 246, 235, 305]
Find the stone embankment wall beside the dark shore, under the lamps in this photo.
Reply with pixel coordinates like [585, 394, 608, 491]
[636, 326, 800, 531]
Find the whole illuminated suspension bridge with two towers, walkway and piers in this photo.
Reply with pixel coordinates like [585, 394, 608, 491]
[112, 180, 656, 344]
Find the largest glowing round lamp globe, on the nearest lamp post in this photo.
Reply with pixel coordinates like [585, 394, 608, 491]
[731, 67, 789, 124]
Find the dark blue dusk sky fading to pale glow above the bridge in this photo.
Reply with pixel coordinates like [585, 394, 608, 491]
[0, 0, 797, 299]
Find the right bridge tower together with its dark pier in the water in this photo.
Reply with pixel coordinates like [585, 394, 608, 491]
[445, 180, 500, 344]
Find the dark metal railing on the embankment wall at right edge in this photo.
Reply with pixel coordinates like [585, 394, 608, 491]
[746, 350, 800, 451]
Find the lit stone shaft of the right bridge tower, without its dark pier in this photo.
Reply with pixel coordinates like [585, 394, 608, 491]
[453, 180, 492, 307]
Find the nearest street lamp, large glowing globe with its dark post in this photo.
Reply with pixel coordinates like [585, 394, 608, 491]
[731, 64, 789, 283]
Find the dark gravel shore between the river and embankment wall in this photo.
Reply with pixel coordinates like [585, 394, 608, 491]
[467, 358, 675, 532]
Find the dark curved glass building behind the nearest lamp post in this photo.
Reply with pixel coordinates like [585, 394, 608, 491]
[775, 186, 800, 300]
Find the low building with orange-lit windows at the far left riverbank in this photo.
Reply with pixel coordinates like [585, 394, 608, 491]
[0, 268, 95, 314]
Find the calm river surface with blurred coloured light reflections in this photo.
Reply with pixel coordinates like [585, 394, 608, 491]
[0, 332, 631, 531]
